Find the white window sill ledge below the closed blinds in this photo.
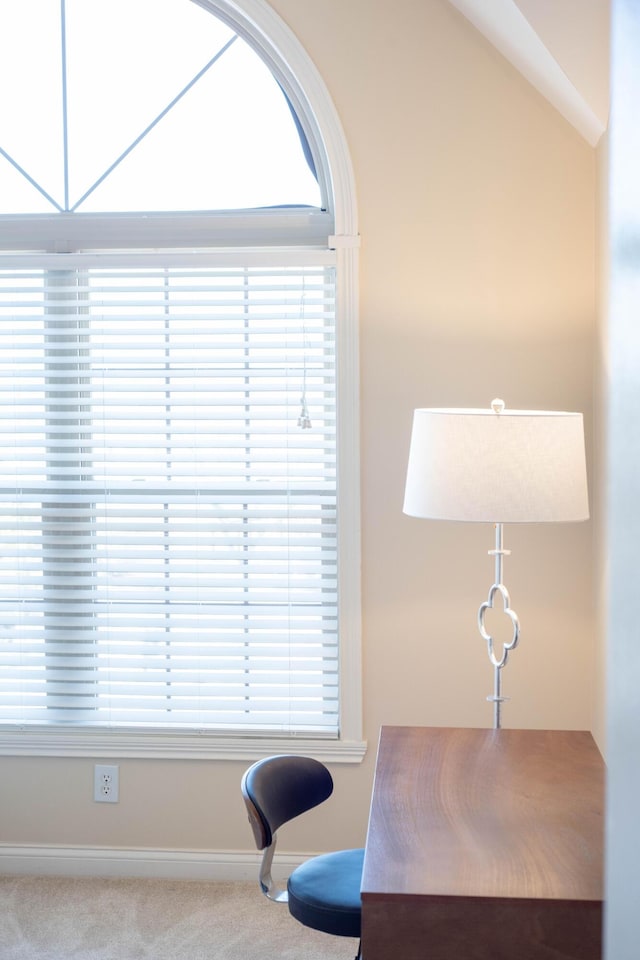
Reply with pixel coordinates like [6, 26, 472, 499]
[0, 727, 367, 763]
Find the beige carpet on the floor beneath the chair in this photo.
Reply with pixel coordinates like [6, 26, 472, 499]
[0, 877, 358, 960]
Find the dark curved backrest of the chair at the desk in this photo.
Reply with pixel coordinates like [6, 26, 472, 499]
[242, 755, 333, 850]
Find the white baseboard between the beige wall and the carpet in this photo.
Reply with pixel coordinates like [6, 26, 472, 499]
[0, 843, 309, 883]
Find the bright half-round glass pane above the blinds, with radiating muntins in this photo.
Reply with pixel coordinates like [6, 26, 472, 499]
[0, 0, 320, 214]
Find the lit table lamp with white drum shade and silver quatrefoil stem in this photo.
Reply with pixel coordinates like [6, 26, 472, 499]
[403, 400, 589, 728]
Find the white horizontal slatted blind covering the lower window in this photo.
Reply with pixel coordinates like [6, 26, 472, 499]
[0, 258, 339, 736]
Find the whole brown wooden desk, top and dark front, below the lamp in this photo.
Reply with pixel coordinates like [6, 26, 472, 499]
[362, 727, 604, 960]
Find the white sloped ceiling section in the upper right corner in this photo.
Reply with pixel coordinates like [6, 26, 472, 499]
[449, 0, 609, 146]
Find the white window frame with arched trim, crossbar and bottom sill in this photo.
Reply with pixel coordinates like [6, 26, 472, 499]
[0, 0, 366, 762]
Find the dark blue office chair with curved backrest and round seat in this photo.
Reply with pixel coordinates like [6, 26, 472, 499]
[242, 756, 364, 960]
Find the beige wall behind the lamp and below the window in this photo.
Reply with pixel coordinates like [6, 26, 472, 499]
[0, 0, 595, 868]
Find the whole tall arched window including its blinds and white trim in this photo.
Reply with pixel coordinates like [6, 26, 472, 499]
[0, 0, 362, 758]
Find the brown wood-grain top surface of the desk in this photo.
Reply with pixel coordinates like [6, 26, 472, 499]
[362, 727, 604, 901]
